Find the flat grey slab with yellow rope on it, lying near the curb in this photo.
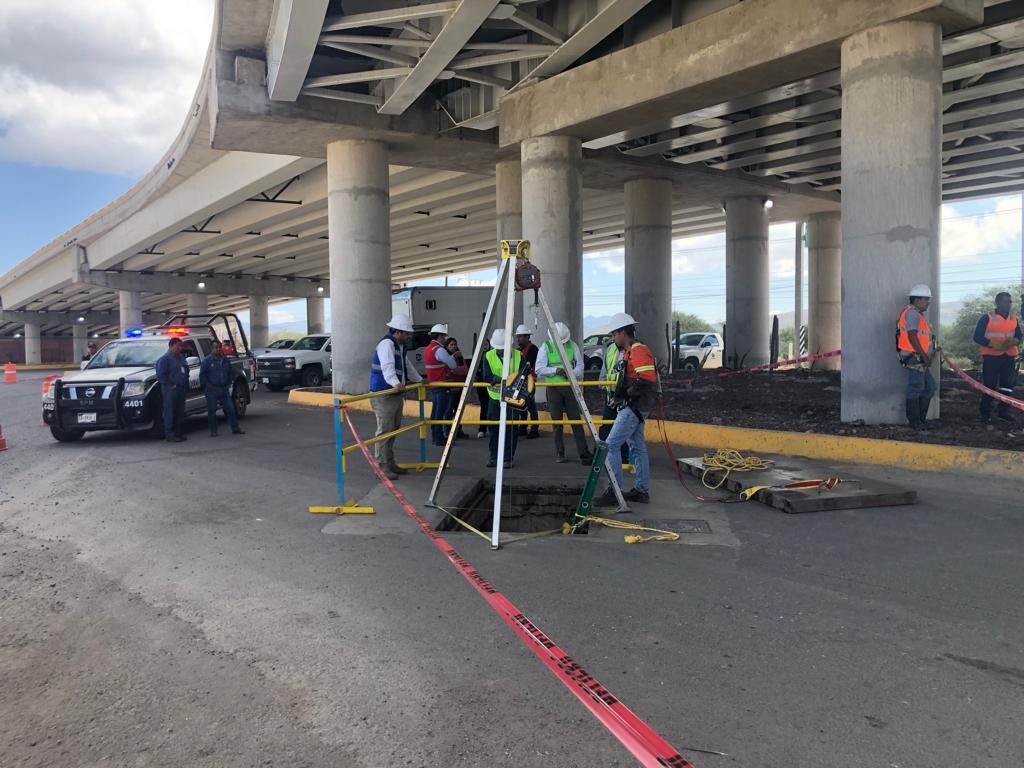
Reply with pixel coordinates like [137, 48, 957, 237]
[679, 457, 918, 514]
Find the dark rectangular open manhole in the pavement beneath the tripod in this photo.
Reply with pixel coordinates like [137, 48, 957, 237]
[437, 479, 584, 534]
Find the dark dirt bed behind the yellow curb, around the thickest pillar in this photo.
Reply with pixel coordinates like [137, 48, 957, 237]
[587, 370, 1024, 451]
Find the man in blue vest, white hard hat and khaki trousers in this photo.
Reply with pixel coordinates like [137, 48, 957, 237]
[370, 314, 422, 480]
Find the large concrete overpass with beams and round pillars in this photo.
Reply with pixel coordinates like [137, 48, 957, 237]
[0, 0, 1024, 422]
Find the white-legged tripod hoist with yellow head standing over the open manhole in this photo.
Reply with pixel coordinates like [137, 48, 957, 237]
[427, 240, 628, 549]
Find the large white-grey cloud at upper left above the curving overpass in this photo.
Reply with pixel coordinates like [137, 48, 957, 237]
[0, 0, 213, 175]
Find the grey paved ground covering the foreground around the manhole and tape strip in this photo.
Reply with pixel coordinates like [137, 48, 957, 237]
[0, 374, 1024, 768]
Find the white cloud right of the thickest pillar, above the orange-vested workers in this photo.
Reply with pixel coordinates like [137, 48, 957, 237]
[942, 196, 1021, 264]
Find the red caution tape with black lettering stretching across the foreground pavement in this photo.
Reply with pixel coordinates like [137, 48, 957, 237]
[342, 409, 692, 768]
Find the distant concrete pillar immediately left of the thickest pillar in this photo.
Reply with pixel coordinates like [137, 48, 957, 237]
[807, 213, 843, 371]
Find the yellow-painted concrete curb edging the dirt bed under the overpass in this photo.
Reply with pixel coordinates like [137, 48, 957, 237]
[288, 389, 1024, 477]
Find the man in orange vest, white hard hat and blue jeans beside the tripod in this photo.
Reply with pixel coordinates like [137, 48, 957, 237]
[594, 312, 657, 507]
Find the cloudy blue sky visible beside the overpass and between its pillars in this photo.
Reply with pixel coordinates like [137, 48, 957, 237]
[0, 0, 1021, 331]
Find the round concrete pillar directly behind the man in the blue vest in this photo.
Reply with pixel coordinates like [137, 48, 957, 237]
[327, 139, 391, 394]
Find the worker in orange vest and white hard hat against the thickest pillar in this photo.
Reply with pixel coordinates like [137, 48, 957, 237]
[896, 285, 938, 429]
